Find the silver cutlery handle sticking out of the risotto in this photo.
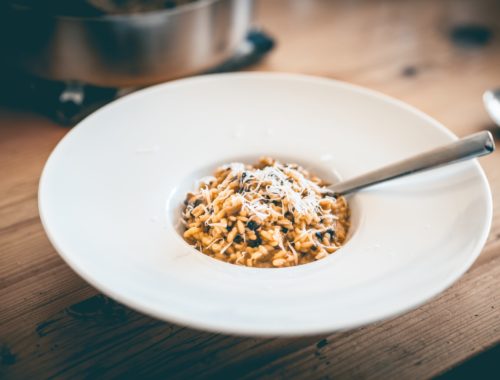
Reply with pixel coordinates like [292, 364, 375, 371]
[328, 131, 495, 194]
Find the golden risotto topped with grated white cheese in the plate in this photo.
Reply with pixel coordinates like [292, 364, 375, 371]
[182, 157, 350, 268]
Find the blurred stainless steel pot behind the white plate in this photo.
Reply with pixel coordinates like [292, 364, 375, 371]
[0, 0, 253, 87]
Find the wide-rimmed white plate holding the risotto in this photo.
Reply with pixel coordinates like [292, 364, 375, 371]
[39, 73, 492, 335]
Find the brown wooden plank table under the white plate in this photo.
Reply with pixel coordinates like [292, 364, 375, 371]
[0, 0, 500, 379]
